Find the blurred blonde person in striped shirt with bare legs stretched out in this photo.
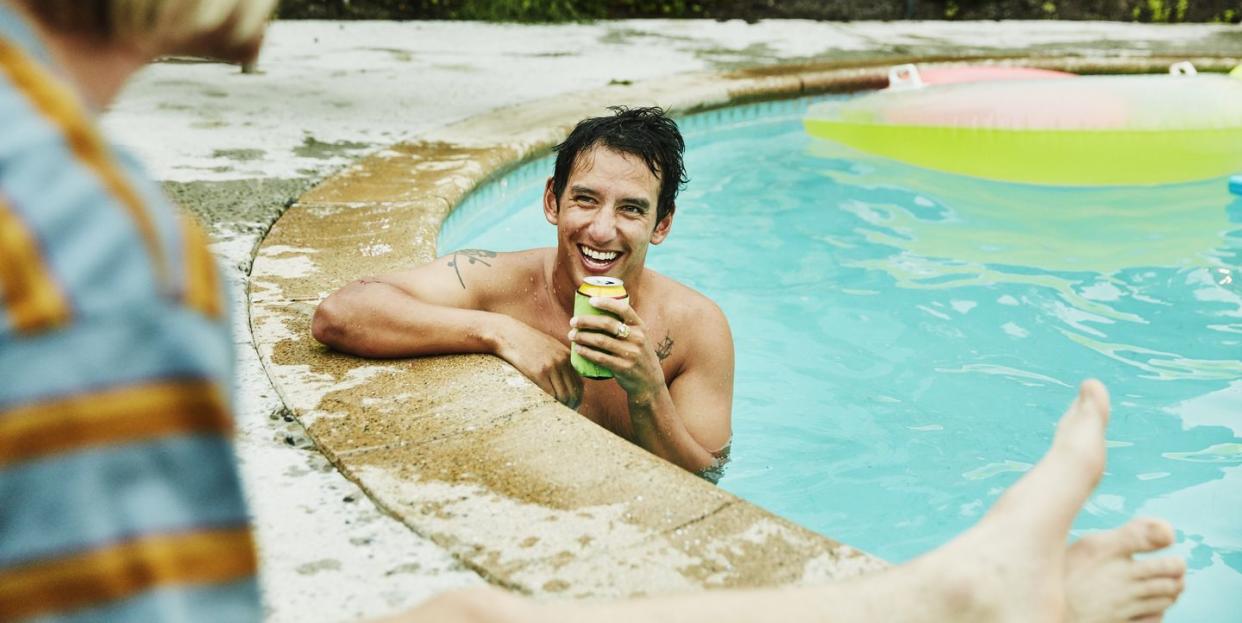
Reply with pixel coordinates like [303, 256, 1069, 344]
[0, 0, 1185, 623]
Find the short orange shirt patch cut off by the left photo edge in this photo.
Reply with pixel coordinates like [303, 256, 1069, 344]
[0, 199, 72, 333]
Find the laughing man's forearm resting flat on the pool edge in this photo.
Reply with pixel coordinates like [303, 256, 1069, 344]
[312, 282, 513, 357]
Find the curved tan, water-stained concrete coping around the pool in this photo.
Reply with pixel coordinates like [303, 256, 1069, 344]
[250, 56, 1238, 597]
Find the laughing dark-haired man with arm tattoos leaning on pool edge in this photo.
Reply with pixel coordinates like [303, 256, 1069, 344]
[312, 108, 733, 472]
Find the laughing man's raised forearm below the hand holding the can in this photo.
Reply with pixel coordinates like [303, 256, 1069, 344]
[628, 387, 715, 473]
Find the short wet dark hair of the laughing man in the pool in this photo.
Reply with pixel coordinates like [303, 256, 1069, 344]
[551, 105, 689, 222]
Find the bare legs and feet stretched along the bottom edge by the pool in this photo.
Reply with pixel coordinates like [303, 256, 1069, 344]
[406, 381, 1182, 623]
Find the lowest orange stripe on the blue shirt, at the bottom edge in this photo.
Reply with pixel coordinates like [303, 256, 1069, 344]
[0, 527, 257, 621]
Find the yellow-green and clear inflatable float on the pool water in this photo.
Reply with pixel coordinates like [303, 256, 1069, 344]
[805, 68, 1242, 186]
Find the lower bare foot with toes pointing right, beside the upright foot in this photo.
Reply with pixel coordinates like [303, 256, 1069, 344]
[1066, 519, 1186, 623]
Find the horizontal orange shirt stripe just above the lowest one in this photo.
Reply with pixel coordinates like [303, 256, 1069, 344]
[0, 380, 232, 466]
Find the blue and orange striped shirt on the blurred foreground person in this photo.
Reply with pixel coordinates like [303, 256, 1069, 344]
[0, 2, 261, 622]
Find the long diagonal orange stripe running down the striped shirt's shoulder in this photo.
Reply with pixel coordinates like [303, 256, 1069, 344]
[0, 40, 168, 285]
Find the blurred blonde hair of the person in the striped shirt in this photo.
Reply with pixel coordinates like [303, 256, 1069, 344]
[21, 0, 277, 61]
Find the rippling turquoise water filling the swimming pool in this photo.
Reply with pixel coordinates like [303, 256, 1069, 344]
[440, 101, 1242, 623]
